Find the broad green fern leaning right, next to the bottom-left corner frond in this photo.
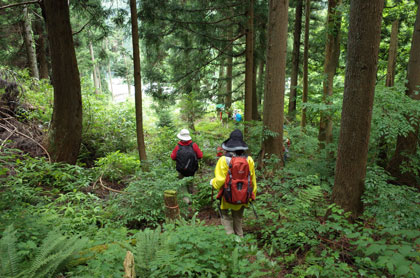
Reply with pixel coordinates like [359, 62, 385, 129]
[19, 230, 87, 278]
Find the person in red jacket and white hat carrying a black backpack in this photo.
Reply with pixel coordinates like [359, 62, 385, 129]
[171, 129, 203, 193]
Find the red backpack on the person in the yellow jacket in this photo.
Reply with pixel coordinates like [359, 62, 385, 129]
[217, 156, 255, 205]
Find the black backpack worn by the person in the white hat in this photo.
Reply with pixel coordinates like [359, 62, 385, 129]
[176, 143, 198, 177]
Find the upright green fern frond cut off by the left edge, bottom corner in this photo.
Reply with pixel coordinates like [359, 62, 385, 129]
[0, 225, 19, 277]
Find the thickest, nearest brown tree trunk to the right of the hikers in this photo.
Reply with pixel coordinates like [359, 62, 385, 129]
[332, 0, 384, 217]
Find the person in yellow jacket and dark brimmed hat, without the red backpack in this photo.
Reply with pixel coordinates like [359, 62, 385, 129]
[210, 129, 257, 237]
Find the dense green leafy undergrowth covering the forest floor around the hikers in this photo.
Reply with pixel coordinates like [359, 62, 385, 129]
[0, 78, 420, 278]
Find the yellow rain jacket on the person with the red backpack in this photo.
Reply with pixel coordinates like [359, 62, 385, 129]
[211, 156, 257, 210]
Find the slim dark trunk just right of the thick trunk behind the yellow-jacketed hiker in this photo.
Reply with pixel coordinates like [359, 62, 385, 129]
[288, 0, 303, 120]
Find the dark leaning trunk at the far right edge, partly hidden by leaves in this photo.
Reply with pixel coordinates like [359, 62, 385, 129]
[387, 2, 420, 187]
